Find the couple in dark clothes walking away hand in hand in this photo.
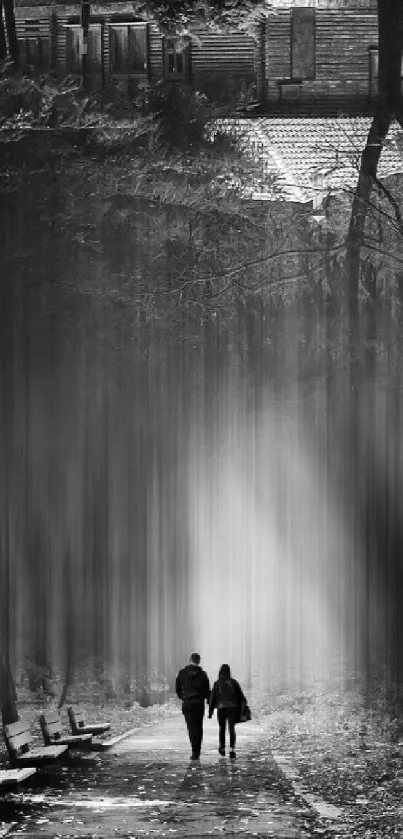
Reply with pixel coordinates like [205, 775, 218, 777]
[175, 653, 247, 760]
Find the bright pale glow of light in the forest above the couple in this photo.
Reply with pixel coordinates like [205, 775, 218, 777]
[186, 392, 374, 697]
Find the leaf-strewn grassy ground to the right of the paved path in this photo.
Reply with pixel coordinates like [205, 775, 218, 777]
[261, 684, 403, 839]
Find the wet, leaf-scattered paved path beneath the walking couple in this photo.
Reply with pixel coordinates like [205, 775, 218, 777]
[3, 714, 311, 839]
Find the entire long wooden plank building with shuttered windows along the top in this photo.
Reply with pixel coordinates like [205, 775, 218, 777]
[16, 0, 377, 112]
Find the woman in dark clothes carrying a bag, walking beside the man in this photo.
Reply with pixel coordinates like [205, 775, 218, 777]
[209, 664, 246, 758]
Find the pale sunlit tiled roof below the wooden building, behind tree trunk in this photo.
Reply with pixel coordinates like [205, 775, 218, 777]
[210, 117, 403, 205]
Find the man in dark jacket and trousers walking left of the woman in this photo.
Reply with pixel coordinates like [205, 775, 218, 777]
[175, 653, 210, 760]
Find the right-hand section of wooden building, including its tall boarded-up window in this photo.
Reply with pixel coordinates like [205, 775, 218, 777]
[264, 0, 378, 106]
